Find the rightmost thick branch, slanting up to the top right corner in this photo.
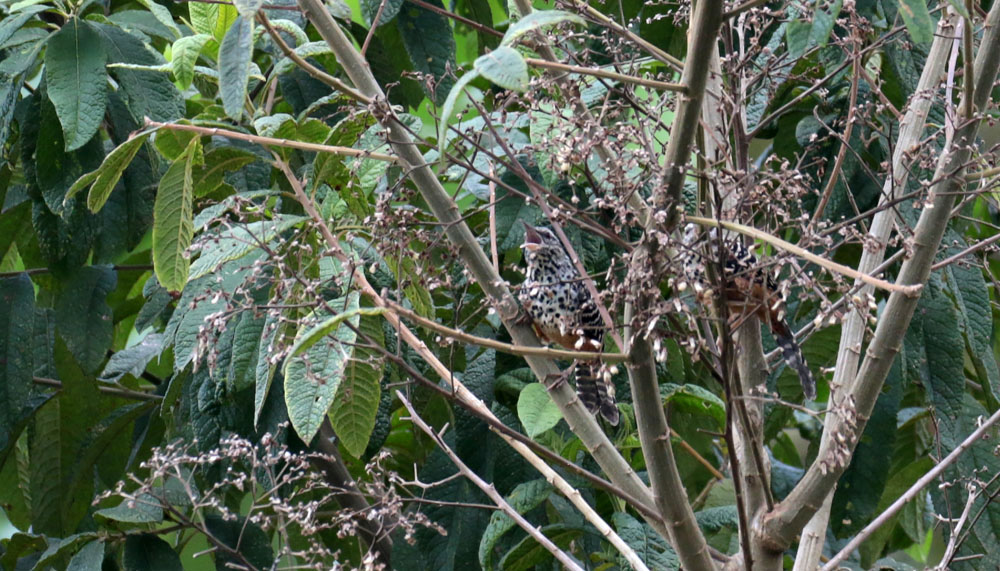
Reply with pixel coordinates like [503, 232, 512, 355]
[764, 3, 1000, 551]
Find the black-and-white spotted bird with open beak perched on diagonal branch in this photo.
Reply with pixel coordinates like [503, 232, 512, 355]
[518, 222, 619, 425]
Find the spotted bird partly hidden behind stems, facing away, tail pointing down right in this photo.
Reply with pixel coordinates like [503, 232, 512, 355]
[682, 224, 816, 400]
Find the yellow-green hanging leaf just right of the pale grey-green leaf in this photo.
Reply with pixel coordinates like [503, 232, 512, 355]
[330, 308, 385, 458]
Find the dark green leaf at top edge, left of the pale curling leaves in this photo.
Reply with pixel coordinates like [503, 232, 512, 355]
[396, 0, 455, 104]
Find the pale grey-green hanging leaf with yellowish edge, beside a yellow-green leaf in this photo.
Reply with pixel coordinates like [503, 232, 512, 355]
[284, 292, 361, 442]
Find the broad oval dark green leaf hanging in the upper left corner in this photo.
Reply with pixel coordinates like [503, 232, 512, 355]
[45, 18, 108, 151]
